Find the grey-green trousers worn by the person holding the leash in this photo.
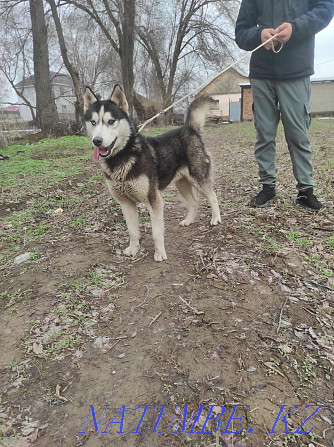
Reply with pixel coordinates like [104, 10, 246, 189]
[251, 77, 314, 191]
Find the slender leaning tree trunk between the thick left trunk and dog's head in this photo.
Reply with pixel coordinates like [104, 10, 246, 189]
[47, 0, 84, 124]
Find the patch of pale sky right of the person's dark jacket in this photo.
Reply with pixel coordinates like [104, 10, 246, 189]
[312, 19, 334, 78]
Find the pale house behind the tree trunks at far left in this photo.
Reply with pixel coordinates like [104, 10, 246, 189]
[15, 72, 76, 122]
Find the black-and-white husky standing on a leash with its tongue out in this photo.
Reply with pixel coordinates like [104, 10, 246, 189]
[84, 85, 221, 261]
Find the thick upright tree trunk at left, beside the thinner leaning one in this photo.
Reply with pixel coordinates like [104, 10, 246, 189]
[29, 0, 59, 135]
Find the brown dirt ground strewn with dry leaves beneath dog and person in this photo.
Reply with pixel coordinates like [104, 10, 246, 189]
[0, 120, 334, 447]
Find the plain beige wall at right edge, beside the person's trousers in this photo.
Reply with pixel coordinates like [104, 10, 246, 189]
[310, 81, 334, 115]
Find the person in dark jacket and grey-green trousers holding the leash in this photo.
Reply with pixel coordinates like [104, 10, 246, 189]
[235, 0, 334, 211]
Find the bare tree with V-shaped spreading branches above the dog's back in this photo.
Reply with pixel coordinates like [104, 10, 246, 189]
[136, 0, 232, 111]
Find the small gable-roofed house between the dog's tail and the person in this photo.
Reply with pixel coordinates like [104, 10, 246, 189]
[199, 68, 249, 121]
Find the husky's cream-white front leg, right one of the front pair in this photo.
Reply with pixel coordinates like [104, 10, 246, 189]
[147, 192, 167, 261]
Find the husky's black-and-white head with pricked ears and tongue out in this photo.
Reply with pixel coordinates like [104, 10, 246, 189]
[84, 84, 131, 161]
